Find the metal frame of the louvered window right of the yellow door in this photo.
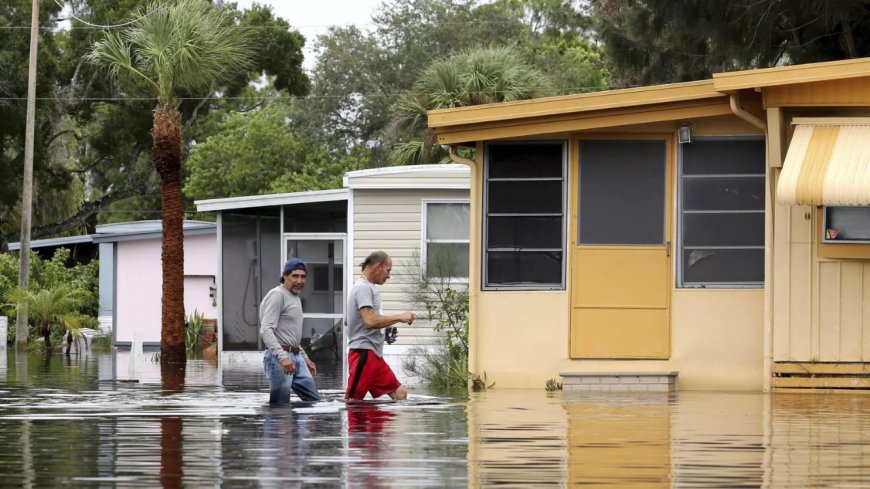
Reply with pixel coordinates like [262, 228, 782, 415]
[674, 135, 767, 289]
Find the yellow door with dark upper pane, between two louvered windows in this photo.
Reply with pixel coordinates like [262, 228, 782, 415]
[571, 137, 672, 359]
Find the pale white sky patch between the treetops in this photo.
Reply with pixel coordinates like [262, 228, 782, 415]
[235, 0, 383, 70]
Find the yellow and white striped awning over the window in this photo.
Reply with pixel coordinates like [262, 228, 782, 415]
[776, 118, 870, 206]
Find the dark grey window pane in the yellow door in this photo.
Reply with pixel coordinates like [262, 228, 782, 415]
[579, 141, 666, 245]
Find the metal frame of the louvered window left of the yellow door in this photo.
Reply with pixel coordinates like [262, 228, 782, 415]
[480, 139, 569, 291]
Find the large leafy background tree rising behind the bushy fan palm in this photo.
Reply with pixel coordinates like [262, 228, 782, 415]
[291, 0, 606, 160]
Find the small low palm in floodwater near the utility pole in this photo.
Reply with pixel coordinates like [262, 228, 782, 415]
[10, 285, 83, 355]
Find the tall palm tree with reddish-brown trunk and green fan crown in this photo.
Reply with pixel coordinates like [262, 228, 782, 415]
[88, 0, 252, 364]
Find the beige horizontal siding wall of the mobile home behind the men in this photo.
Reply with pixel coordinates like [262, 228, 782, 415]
[352, 187, 468, 345]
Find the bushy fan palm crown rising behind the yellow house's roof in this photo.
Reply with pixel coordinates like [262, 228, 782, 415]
[388, 47, 550, 165]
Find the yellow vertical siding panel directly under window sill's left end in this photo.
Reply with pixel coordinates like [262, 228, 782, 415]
[814, 262, 842, 362]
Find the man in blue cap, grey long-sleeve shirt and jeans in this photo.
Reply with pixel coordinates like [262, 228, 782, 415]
[260, 258, 320, 403]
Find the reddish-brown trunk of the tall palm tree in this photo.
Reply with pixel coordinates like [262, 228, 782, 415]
[152, 104, 186, 364]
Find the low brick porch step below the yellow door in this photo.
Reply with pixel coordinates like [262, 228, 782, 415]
[559, 371, 680, 392]
